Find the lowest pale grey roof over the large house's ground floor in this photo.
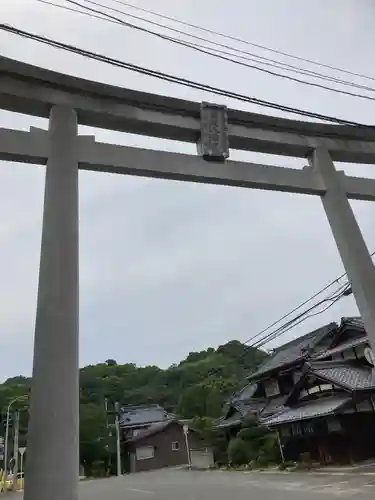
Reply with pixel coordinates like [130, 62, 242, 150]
[262, 394, 351, 426]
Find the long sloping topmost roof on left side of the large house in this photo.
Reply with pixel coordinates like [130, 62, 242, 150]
[248, 323, 337, 379]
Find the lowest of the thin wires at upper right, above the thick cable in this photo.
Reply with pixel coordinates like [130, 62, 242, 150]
[60, 0, 375, 101]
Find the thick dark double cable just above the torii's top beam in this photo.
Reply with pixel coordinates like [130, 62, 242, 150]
[0, 23, 373, 129]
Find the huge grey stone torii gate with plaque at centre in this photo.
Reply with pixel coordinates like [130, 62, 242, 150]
[0, 58, 375, 500]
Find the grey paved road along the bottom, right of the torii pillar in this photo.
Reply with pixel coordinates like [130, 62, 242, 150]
[78, 470, 375, 500]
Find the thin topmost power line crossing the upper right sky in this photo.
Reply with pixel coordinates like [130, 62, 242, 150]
[106, 0, 375, 81]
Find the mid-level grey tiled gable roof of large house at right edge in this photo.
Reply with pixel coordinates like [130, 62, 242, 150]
[310, 361, 375, 391]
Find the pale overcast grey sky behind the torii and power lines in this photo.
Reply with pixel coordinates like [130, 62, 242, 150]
[0, 0, 375, 379]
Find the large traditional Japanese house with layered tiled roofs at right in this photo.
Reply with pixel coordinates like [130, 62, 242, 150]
[219, 318, 375, 463]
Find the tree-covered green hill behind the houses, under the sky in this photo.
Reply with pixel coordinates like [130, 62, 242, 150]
[0, 340, 266, 425]
